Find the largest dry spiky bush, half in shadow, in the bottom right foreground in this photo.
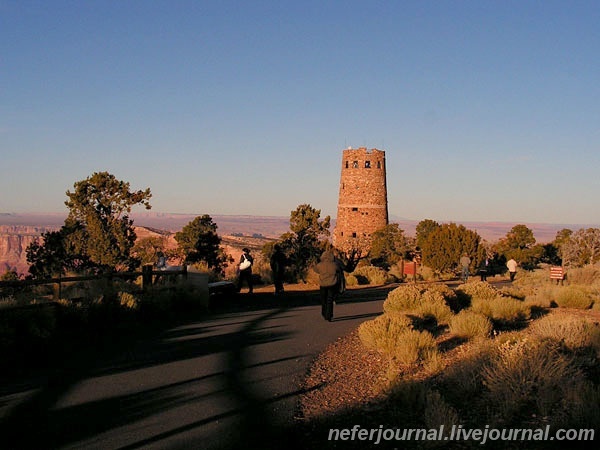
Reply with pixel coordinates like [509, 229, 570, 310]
[436, 332, 600, 428]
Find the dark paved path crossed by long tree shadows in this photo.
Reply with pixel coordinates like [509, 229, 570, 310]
[0, 286, 393, 450]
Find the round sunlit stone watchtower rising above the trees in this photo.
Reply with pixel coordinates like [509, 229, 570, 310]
[333, 147, 388, 251]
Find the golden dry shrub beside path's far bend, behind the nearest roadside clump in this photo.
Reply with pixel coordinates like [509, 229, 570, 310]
[383, 285, 452, 324]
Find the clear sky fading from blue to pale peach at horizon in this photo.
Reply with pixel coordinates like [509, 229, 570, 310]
[0, 0, 600, 224]
